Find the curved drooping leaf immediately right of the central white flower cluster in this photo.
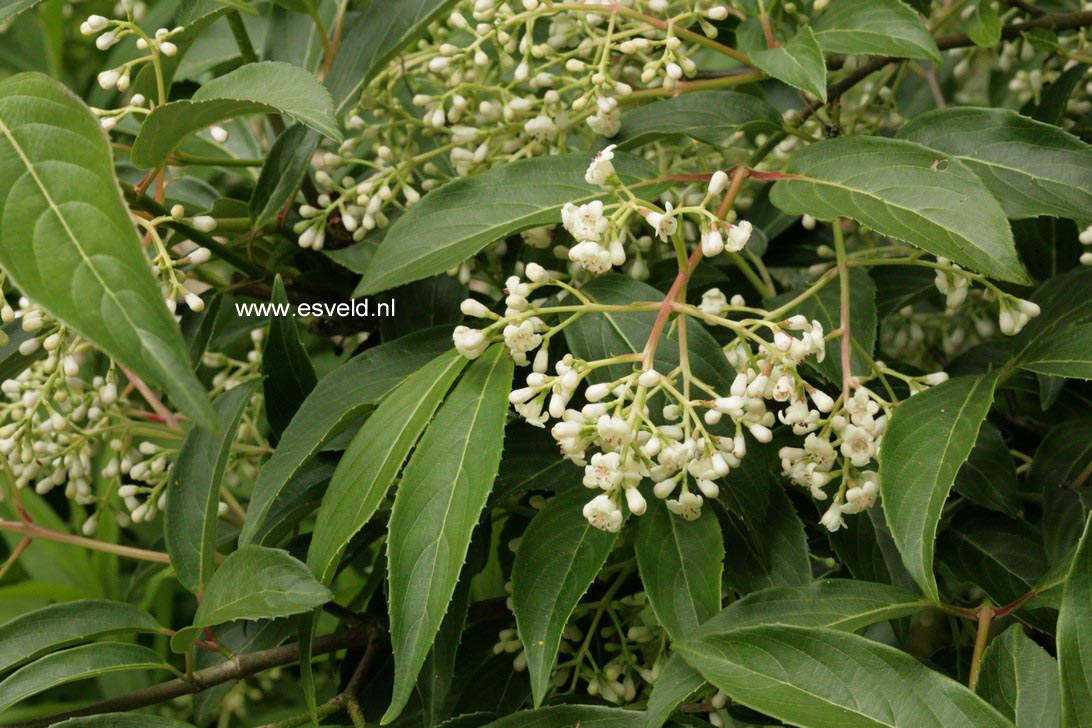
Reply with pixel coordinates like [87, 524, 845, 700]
[879, 372, 997, 599]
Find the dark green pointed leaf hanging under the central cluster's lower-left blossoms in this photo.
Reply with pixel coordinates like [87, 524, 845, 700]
[512, 485, 615, 705]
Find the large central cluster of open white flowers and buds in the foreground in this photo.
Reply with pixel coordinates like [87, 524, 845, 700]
[453, 162, 956, 532]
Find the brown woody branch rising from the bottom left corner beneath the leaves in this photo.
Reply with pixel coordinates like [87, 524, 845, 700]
[3, 626, 377, 728]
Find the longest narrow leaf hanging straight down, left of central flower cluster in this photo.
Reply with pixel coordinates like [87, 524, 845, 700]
[383, 345, 512, 723]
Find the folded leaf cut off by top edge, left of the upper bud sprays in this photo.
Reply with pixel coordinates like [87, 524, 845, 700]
[327, 0, 455, 114]
